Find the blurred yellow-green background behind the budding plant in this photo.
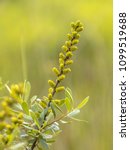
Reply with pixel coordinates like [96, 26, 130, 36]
[0, 0, 112, 150]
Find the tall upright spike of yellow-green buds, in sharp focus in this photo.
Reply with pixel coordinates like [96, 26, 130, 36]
[48, 21, 83, 102]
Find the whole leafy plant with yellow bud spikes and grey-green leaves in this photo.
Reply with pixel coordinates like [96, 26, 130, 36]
[0, 21, 89, 150]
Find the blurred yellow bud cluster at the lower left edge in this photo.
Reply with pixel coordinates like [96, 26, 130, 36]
[0, 84, 23, 145]
